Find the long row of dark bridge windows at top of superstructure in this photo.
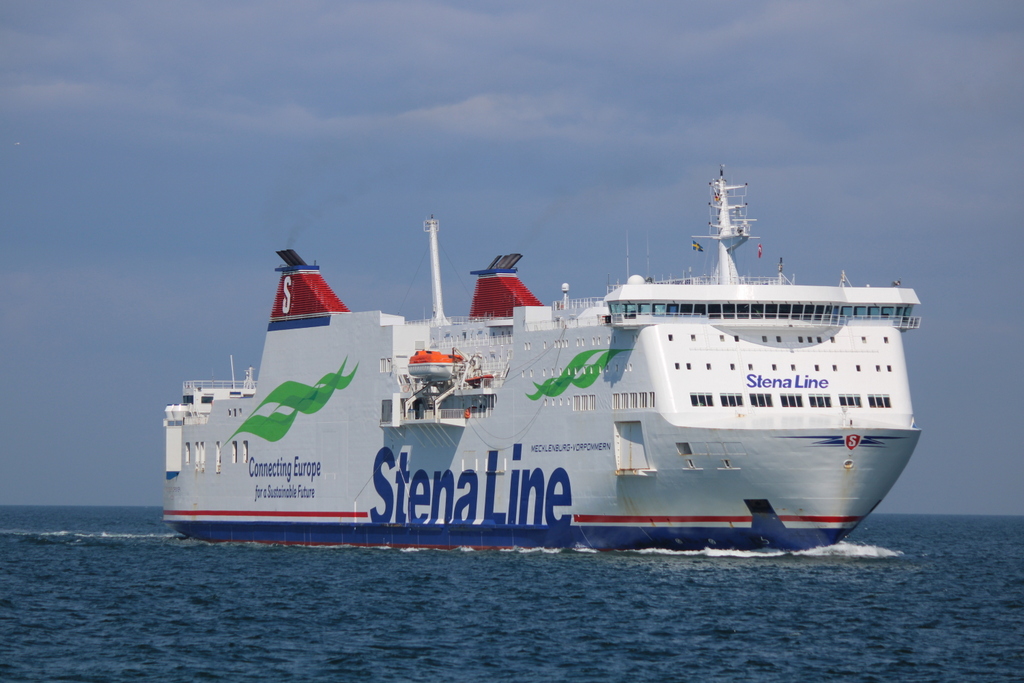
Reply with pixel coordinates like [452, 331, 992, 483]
[608, 301, 913, 321]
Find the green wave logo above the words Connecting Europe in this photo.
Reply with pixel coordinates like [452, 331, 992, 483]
[228, 357, 359, 441]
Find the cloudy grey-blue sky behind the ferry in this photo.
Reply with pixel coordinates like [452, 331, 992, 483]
[0, 0, 1024, 515]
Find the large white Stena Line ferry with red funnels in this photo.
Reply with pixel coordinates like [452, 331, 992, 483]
[164, 170, 921, 550]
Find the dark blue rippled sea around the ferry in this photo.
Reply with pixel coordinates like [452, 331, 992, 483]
[0, 507, 1024, 682]
